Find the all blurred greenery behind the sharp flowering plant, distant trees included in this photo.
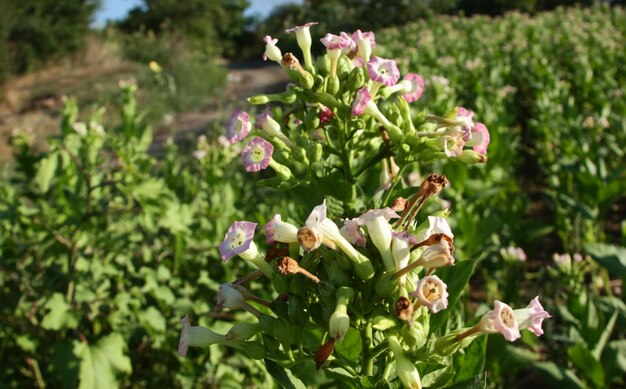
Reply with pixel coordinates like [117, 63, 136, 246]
[0, 0, 626, 388]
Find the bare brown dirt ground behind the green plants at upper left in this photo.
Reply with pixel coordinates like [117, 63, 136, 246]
[0, 49, 287, 162]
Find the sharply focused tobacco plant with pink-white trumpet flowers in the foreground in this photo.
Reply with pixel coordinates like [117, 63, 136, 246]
[179, 23, 550, 388]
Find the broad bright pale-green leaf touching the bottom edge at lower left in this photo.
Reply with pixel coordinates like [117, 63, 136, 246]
[74, 333, 132, 389]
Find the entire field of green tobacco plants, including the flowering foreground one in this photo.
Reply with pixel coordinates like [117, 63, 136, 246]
[0, 6, 626, 388]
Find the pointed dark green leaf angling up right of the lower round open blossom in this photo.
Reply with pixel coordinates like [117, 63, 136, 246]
[430, 260, 477, 333]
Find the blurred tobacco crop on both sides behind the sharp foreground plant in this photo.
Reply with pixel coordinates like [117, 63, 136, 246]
[0, 3, 626, 388]
